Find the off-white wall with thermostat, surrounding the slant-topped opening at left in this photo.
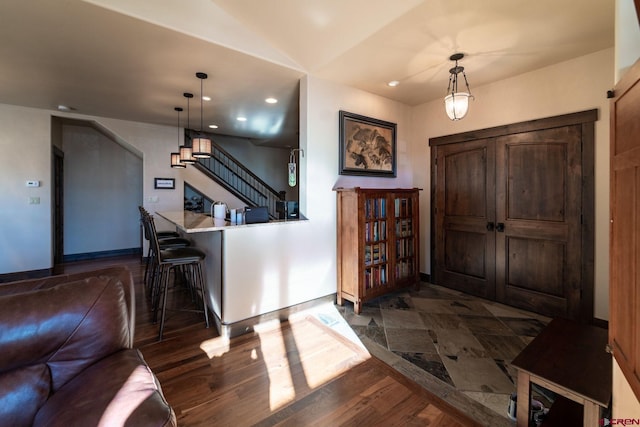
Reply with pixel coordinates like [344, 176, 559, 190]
[0, 104, 222, 274]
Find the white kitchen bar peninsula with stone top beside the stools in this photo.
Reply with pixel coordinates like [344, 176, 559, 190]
[156, 211, 324, 336]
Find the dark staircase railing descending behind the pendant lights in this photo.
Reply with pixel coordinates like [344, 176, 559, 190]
[185, 131, 285, 218]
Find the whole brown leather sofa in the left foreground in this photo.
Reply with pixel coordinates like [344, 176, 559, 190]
[0, 267, 176, 426]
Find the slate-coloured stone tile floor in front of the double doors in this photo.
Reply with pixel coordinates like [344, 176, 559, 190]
[337, 283, 551, 418]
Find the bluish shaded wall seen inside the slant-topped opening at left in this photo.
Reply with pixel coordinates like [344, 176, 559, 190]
[62, 125, 142, 255]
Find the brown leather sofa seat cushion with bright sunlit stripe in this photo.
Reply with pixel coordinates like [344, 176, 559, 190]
[33, 349, 176, 426]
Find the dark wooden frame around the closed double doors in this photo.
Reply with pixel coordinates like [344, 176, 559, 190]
[429, 109, 598, 322]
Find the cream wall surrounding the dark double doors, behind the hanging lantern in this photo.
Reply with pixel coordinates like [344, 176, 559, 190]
[412, 48, 614, 319]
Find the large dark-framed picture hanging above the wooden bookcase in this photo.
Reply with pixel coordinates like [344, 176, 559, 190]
[340, 110, 397, 178]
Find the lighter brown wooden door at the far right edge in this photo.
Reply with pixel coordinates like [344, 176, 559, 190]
[609, 57, 640, 399]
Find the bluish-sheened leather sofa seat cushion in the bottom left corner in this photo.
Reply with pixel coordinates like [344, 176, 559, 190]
[0, 363, 51, 427]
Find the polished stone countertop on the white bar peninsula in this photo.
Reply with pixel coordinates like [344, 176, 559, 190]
[156, 211, 306, 233]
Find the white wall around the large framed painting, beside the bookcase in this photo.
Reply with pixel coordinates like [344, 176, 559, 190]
[300, 77, 413, 304]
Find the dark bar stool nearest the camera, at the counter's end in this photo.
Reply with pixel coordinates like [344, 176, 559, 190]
[148, 216, 209, 341]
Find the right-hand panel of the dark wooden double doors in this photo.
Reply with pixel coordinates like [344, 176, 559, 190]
[496, 126, 582, 318]
